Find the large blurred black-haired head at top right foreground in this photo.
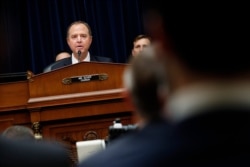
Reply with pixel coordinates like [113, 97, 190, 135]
[144, 0, 250, 76]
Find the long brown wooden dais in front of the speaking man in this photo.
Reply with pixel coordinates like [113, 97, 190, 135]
[0, 62, 135, 166]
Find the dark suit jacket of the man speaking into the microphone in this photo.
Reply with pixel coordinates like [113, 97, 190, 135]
[43, 56, 113, 72]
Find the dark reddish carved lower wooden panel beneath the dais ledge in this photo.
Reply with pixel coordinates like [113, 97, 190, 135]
[42, 112, 132, 166]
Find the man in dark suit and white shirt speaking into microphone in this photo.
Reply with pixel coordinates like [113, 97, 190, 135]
[44, 21, 113, 72]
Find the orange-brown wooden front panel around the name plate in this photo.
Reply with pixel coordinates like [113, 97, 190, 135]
[29, 62, 127, 98]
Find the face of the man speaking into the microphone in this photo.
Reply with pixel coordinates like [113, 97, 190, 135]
[67, 23, 92, 55]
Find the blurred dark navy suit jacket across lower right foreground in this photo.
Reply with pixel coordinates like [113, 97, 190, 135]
[80, 106, 250, 167]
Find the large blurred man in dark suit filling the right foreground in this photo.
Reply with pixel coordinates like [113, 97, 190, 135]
[79, 0, 250, 167]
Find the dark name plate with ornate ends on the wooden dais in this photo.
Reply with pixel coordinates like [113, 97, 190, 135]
[62, 73, 108, 85]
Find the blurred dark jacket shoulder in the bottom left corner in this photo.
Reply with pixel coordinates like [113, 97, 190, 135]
[0, 136, 71, 167]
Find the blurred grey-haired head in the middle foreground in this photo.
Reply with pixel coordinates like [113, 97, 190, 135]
[123, 48, 165, 120]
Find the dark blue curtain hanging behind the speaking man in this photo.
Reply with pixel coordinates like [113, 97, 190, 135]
[0, 0, 144, 74]
